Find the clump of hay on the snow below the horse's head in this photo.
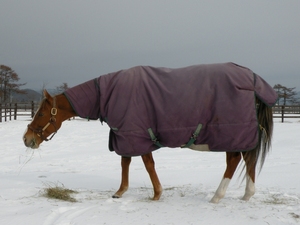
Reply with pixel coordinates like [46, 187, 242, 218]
[44, 185, 78, 202]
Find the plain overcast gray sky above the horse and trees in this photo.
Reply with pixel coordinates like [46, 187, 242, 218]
[0, 0, 300, 90]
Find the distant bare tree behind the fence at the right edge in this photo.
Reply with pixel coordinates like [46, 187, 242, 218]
[273, 84, 299, 105]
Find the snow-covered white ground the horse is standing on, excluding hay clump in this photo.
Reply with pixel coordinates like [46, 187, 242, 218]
[0, 117, 300, 225]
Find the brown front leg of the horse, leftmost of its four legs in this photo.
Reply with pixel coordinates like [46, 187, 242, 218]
[112, 156, 131, 198]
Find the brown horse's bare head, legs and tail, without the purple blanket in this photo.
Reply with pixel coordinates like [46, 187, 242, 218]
[23, 62, 275, 203]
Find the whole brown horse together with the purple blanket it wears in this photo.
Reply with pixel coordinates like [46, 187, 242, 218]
[23, 63, 277, 203]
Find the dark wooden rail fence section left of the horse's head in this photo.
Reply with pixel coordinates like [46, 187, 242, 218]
[0, 102, 38, 122]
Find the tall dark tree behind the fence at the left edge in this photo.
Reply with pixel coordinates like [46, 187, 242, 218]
[0, 65, 26, 103]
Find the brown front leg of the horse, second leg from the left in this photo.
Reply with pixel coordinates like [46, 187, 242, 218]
[142, 153, 162, 200]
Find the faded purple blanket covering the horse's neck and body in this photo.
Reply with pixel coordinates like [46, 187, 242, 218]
[64, 63, 277, 156]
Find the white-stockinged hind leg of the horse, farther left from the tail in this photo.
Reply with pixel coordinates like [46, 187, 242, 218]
[210, 152, 242, 203]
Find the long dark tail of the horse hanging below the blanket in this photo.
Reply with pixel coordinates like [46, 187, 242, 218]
[244, 98, 273, 171]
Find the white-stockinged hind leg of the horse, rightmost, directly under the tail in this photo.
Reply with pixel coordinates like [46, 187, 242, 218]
[242, 153, 256, 201]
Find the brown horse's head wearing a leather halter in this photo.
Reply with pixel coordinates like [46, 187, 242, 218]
[23, 90, 65, 148]
